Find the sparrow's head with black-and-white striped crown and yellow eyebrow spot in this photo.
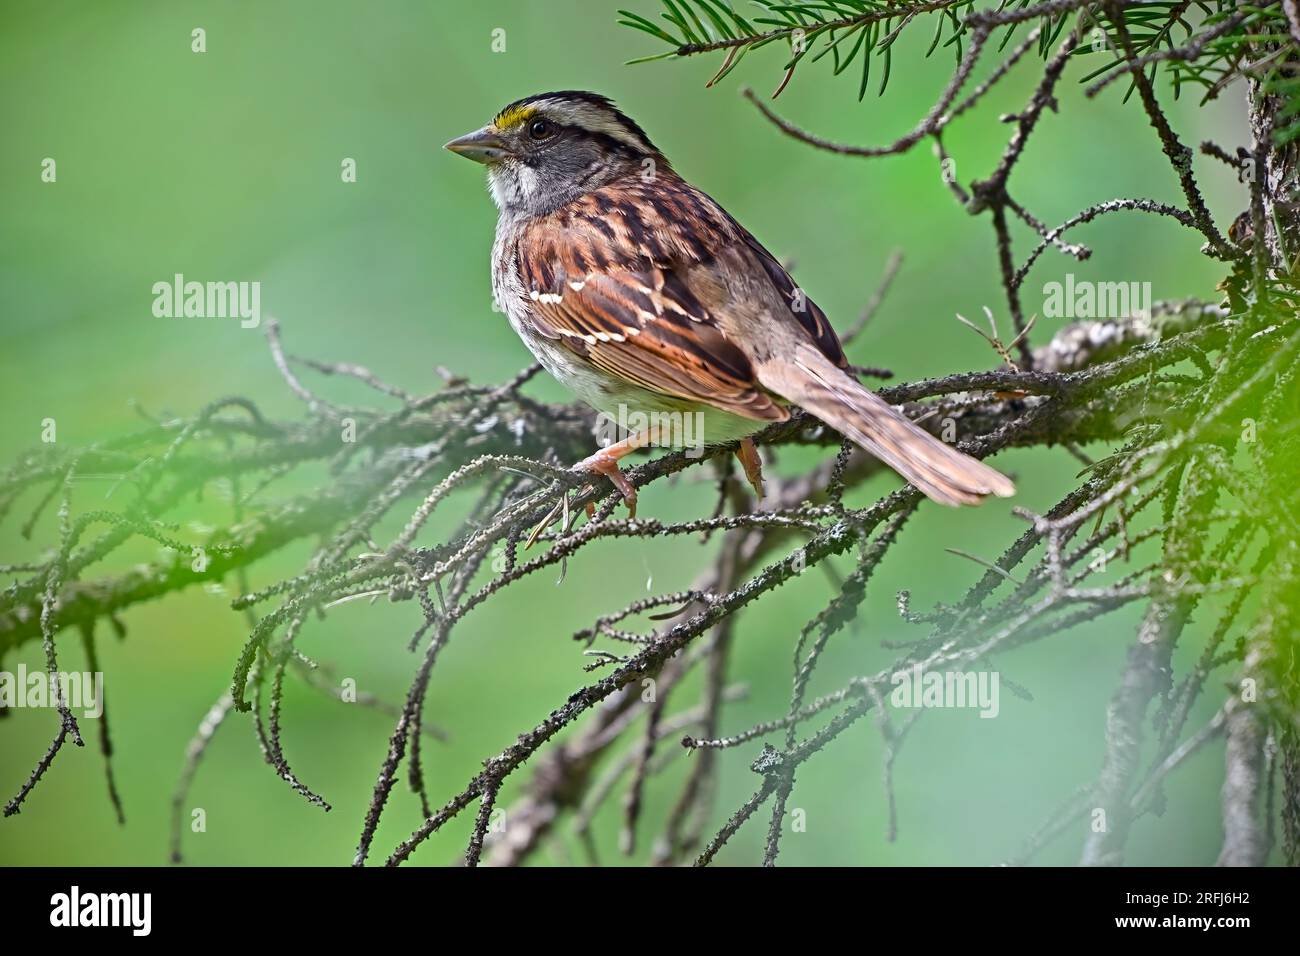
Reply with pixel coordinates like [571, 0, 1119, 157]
[446, 90, 668, 215]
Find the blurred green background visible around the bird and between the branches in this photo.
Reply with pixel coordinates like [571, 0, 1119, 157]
[0, 0, 1247, 865]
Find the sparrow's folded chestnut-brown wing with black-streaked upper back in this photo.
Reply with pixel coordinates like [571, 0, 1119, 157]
[517, 176, 789, 421]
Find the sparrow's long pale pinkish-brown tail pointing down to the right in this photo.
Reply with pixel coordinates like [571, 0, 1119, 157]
[757, 343, 1015, 506]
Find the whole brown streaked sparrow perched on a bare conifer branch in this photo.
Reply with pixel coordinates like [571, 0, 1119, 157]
[445, 90, 1015, 515]
